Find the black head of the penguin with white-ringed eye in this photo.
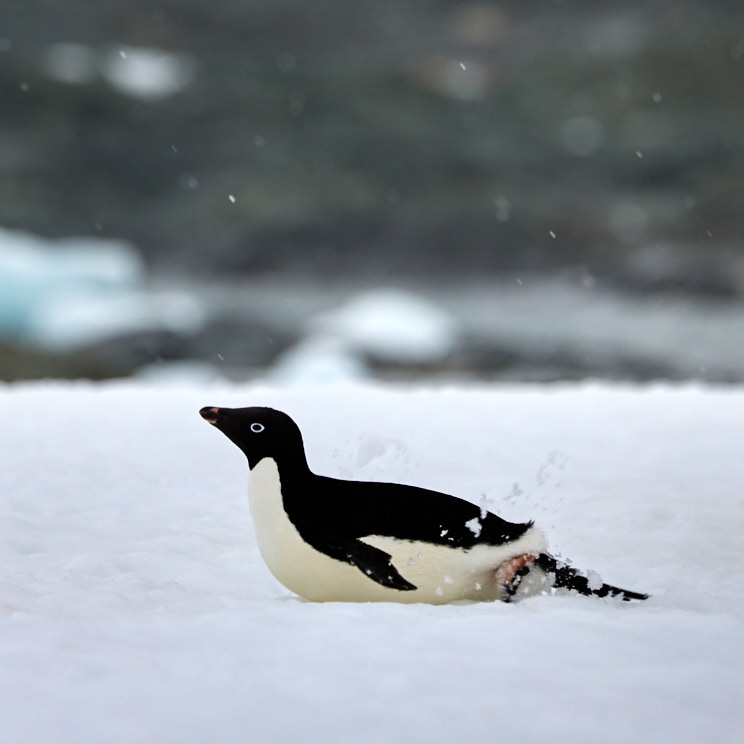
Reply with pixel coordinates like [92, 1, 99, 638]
[199, 406, 307, 470]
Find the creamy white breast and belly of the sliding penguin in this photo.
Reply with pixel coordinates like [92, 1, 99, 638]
[249, 458, 545, 604]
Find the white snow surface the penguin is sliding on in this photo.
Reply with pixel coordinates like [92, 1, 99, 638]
[0, 382, 744, 744]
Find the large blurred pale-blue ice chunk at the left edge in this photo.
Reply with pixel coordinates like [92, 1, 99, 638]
[0, 229, 204, 349]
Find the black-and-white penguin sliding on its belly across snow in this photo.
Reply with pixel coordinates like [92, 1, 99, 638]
[199, 406, 647, 604]
